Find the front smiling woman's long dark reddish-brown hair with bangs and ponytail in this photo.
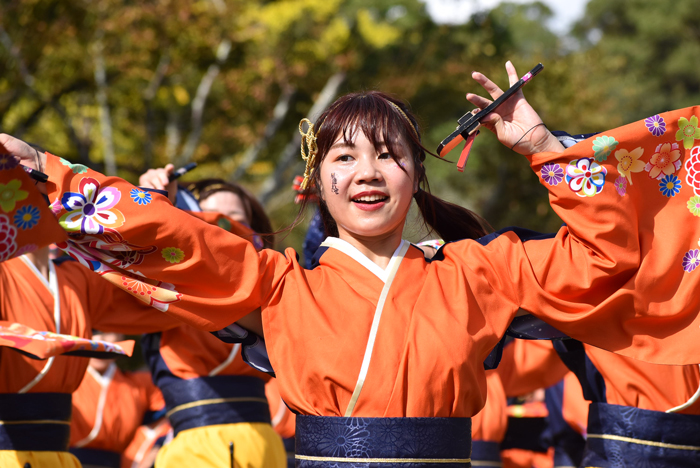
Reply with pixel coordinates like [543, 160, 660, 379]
[299, 91, 488, 245]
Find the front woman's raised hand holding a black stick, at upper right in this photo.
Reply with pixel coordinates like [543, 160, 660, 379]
[467, 61, 564, 155]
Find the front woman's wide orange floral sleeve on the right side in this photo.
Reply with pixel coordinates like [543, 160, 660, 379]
[442, 107, 700, 364]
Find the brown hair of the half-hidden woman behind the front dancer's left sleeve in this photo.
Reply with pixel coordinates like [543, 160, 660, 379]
[187, 179, 275, 249]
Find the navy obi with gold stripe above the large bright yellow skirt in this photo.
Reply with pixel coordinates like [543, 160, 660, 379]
[161, 375, 270, 436]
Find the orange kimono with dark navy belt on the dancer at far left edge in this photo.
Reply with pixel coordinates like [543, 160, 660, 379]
[0, 257, 177, 467]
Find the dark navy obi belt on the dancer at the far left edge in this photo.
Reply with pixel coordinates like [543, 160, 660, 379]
[0, 393, 71, 452]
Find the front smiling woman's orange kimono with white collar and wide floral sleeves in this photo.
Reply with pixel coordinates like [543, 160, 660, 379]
[32, 108, 700, 463]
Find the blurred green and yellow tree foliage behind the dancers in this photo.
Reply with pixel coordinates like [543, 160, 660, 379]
[0, 0, 684, 254]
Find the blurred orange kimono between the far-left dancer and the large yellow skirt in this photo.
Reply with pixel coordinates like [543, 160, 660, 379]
[70, 363, 165, 468]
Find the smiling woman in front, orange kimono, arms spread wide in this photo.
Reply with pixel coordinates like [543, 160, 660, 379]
[0, 63, 700, 468]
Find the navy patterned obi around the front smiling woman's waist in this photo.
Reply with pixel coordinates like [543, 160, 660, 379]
[296, 415, 471, 468]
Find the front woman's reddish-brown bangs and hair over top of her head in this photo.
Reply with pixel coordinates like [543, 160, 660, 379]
[317, 91, 420, 163]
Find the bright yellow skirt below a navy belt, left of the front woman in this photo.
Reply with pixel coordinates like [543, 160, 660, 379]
[154, 423, 287, 468]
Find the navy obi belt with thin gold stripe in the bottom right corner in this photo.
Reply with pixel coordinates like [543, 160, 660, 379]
[581, 403, 700, 468]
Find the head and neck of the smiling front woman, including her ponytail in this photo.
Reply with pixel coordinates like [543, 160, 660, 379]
[300, 91, 486, 268]
